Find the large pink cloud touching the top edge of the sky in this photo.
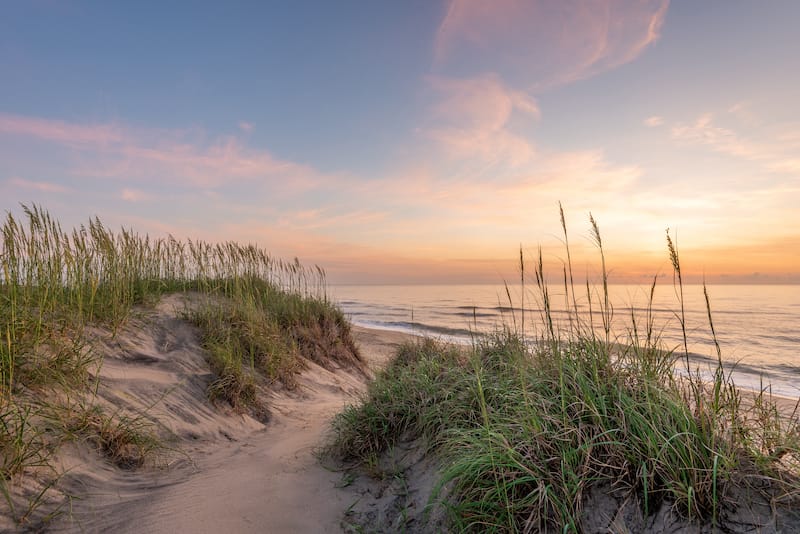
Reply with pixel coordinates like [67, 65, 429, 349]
[434, 0, 669, 88]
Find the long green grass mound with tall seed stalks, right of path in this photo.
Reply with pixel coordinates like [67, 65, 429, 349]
[327, 208, 800, 532]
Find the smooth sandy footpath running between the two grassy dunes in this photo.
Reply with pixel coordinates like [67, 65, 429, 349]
[100, 372, 360, 533]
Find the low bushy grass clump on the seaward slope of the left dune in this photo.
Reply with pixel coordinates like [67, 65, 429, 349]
[187, 278, 361, 409]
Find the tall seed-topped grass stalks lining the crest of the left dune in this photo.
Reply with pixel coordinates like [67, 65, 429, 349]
[0, 205, 338, 397]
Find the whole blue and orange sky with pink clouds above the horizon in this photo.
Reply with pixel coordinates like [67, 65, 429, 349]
[0, 0, 800, 284]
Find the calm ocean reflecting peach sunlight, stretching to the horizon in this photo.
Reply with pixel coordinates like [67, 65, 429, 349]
[329, 284, 800, 397]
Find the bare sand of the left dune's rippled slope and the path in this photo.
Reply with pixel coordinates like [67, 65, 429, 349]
[47, 296, 407, 534]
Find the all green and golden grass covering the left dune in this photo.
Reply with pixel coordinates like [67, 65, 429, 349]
[0, 205, 361, 528]
